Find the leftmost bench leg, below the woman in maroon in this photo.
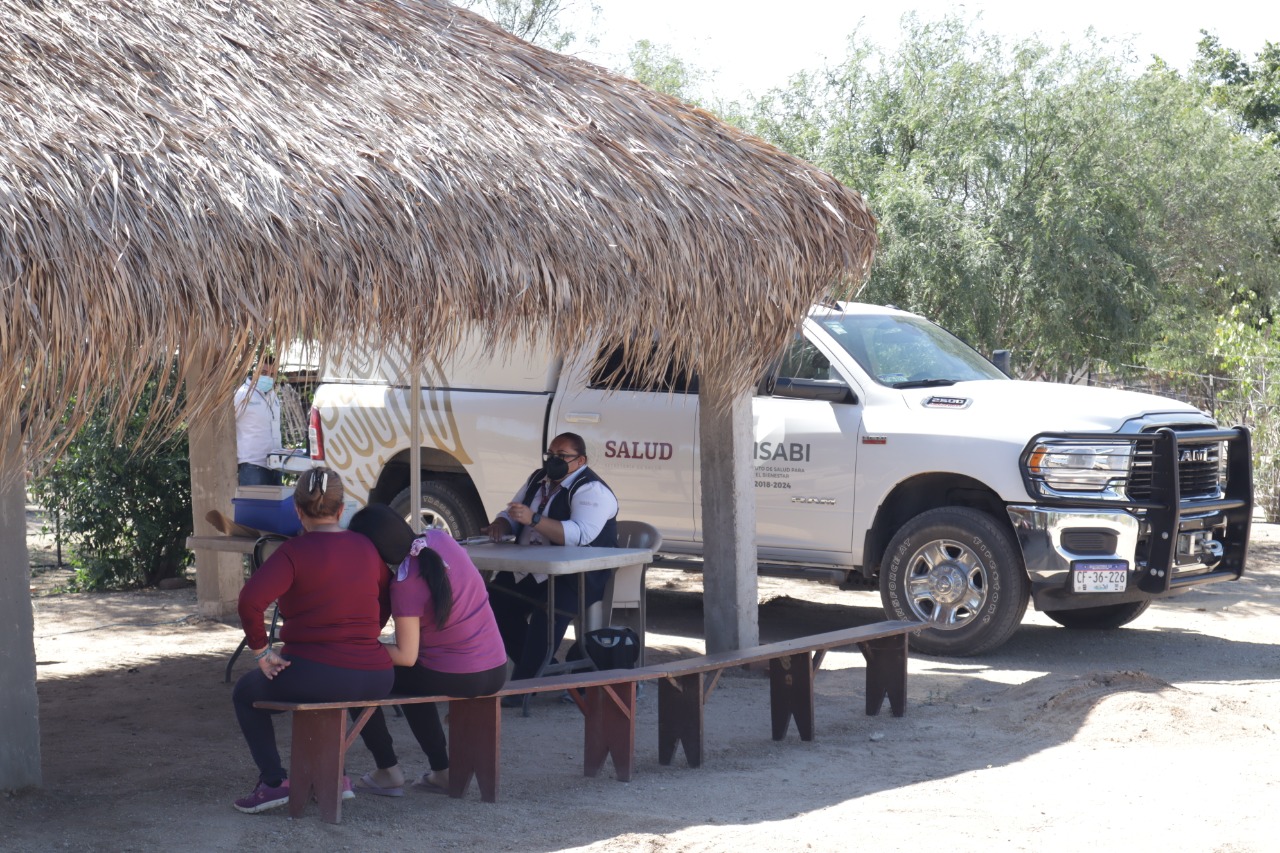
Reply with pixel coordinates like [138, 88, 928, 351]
[289, 710, 347, 824]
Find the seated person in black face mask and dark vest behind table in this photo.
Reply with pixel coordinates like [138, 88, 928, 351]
[484, 433, 618, 698]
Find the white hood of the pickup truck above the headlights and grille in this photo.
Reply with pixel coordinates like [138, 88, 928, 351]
[897, 380, 1208, 441]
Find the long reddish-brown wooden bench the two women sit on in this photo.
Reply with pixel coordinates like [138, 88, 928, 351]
[253, 621, 923, 824]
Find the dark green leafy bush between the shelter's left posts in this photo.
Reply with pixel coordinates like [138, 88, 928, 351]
[31, 361, 191, 589]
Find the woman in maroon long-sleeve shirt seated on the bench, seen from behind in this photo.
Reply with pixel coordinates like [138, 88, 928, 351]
[232, 467, 394, 813]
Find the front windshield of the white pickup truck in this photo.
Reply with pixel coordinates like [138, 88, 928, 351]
[813, 314, 1007, 388]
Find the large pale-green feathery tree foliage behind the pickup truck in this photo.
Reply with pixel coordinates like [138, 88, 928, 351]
[746, 17, 1277, 373]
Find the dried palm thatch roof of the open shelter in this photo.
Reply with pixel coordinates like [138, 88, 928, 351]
[0, 0, 874, 455]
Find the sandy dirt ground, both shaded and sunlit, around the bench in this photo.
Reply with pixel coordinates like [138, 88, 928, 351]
[0, 514, 1280, 853]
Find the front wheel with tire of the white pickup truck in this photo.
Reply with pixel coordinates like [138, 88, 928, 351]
[881, 507, 1030, 656]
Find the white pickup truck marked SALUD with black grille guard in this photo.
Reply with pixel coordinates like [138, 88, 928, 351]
[310, 298, 1252, 654]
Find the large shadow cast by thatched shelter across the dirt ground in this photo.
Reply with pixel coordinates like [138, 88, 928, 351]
[0, 545, 1275, 850]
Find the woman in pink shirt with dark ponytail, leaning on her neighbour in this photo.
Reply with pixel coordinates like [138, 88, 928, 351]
[347, 503, 507, 797]
